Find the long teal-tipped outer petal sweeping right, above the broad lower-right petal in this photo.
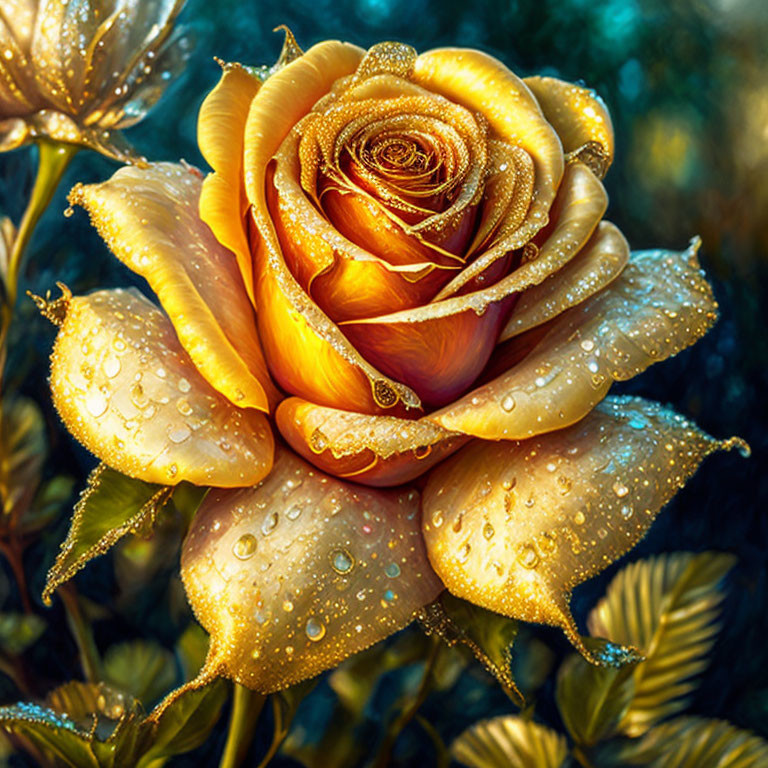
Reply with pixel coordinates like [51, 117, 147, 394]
[427, 239, 717, 440]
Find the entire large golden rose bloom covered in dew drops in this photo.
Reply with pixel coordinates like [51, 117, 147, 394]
[49, 37, 733, 691]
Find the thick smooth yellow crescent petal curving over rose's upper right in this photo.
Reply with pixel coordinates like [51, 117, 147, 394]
[412, 48, 564, 249]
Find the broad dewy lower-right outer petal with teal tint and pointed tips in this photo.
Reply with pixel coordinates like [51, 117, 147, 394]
[422, 397, 742, 656]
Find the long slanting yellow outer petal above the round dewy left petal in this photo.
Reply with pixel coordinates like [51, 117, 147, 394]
[69, 163, 278, 411]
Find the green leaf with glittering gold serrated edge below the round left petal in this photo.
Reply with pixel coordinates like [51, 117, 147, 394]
[43, 464, 173, 605]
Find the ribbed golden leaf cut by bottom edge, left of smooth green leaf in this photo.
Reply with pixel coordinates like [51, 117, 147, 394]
[451, 715, 568, 768]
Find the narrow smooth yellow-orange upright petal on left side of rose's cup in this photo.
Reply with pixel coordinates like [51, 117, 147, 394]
[197, 64, 261, 300]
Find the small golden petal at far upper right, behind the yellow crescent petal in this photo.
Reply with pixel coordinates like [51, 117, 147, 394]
[524, 76, 614, 179]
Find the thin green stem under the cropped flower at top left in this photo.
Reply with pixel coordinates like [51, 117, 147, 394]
[0, 139, 79, 384]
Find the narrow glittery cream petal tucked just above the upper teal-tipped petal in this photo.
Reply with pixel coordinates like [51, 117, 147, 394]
[499, 221, 629, 341]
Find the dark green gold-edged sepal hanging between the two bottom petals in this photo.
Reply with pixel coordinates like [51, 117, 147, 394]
[418, 592, 523, 704]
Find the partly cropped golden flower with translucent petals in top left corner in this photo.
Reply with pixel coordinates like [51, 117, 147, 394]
[0, 0, 189, 160]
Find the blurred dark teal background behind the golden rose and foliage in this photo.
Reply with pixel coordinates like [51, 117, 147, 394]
[0, 0, 768, 766]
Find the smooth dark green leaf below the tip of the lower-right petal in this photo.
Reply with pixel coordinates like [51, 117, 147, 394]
[556, 637, 641, 747]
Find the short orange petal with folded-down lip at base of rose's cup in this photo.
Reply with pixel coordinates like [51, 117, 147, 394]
[275, 397, 469, 486]
